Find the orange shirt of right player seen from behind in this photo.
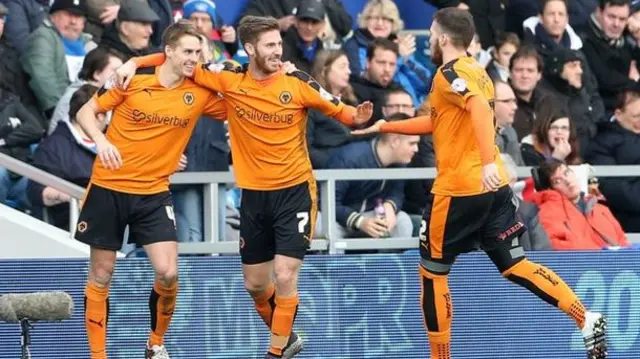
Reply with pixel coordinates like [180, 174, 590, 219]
[429, 56, 508, 196]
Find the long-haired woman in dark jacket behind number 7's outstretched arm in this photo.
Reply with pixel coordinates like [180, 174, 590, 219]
[307, 50, 358, 169]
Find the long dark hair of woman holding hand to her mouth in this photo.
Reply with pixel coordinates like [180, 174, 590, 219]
[531, 103, 581, 165]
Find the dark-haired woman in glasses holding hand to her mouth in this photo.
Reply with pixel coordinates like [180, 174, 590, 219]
[521, 106, 581, 166]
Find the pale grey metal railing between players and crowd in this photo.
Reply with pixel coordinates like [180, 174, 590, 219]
[0, 153, 640, 254]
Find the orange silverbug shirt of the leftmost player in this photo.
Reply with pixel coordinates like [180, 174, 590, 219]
[91, 67, 226, 194]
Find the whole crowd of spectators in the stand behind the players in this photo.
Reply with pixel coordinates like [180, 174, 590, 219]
[0, 0, 640, 250]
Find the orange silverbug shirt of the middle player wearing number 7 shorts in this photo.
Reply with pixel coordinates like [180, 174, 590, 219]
[193, 65, 345, 190]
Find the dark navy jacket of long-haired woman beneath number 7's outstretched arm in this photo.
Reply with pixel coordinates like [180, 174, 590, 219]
[307, 110, 351, 169]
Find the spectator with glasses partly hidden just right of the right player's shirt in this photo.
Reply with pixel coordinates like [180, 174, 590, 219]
[493, 81, 524, 166]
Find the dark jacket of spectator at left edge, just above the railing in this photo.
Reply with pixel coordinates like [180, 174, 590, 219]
[0, 94, 44, 166]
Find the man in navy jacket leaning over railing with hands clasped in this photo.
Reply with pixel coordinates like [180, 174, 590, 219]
[320, 113, 420, 238]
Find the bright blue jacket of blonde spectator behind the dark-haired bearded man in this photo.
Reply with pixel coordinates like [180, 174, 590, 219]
[343, 29, 432, 104]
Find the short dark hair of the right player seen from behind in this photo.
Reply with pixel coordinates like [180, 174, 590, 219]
[433, 7, 476, 50]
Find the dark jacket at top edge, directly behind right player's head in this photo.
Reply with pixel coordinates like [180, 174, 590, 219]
[425, 0, 507, 49]
